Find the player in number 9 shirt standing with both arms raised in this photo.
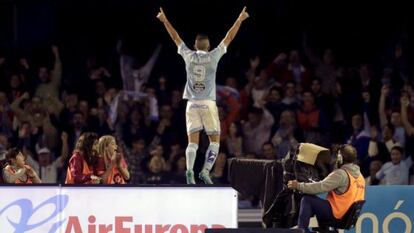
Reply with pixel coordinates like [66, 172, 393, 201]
[157, 7, 249, 184]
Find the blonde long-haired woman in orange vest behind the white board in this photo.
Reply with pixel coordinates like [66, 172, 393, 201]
[98, 135, 129, 184]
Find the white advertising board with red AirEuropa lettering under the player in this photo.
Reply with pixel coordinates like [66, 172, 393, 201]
[0, 185, 237, 233]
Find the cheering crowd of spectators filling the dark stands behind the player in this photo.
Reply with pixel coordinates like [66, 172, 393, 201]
[0, 26, 414, 197]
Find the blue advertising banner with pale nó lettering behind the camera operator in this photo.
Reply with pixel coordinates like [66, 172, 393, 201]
[346, 185, 414, 233]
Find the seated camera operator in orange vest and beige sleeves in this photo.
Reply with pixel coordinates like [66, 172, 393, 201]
[288, 145, 365, 232]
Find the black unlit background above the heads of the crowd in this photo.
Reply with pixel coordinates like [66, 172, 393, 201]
[0, 0, 413, 86]
